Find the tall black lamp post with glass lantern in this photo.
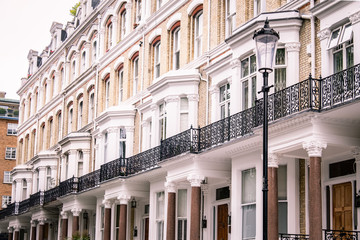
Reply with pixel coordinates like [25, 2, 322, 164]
[253, 18, 279, 240]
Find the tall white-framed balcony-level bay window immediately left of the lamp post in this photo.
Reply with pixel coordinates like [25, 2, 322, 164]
[241, 55, 256, 110]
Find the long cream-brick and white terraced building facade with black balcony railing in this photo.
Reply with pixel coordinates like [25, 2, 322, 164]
[0, 0, 360, 240]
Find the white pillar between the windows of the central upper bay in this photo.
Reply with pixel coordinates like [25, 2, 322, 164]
[165, 96, 180, 138]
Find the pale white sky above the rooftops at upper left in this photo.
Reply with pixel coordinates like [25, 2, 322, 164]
[0, 0, 79, 100]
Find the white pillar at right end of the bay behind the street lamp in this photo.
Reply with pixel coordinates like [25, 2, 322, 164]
[286, 42, 300, 86]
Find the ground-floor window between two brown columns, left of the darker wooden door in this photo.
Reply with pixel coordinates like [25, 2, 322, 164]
[177, 189, 187, 240]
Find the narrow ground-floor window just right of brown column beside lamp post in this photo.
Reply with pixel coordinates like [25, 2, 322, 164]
[278, 165, 288, 233]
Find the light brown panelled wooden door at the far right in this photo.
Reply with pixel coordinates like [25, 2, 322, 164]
[333, 182, 353, 231]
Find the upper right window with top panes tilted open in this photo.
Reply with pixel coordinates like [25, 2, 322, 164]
[328, 24, 354, 73]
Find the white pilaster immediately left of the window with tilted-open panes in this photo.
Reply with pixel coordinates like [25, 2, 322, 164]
[318, 28, 332, 76]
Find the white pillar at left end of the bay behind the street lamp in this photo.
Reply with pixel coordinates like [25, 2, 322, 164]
[231, 58, 242, 114]
